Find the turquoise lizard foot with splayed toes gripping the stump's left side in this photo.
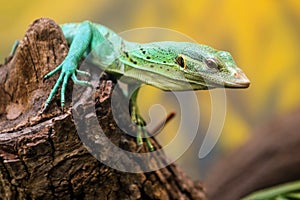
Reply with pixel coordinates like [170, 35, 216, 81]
[42, 58, 91, 113]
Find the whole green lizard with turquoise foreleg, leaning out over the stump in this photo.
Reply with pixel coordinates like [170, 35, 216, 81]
[43, 21, 250, 150]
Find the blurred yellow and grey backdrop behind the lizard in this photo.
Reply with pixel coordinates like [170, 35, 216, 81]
[0, 0, 300, 177]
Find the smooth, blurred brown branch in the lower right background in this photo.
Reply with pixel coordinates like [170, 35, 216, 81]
[205, 110, 300, 200]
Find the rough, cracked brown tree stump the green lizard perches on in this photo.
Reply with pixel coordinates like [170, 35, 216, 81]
[0, 19, 205, 199]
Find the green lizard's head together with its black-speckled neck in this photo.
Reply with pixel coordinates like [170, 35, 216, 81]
[123, 42, 250, 90]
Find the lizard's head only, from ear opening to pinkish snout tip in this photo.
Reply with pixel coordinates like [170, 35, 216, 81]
[175, 43, 250, 88]
